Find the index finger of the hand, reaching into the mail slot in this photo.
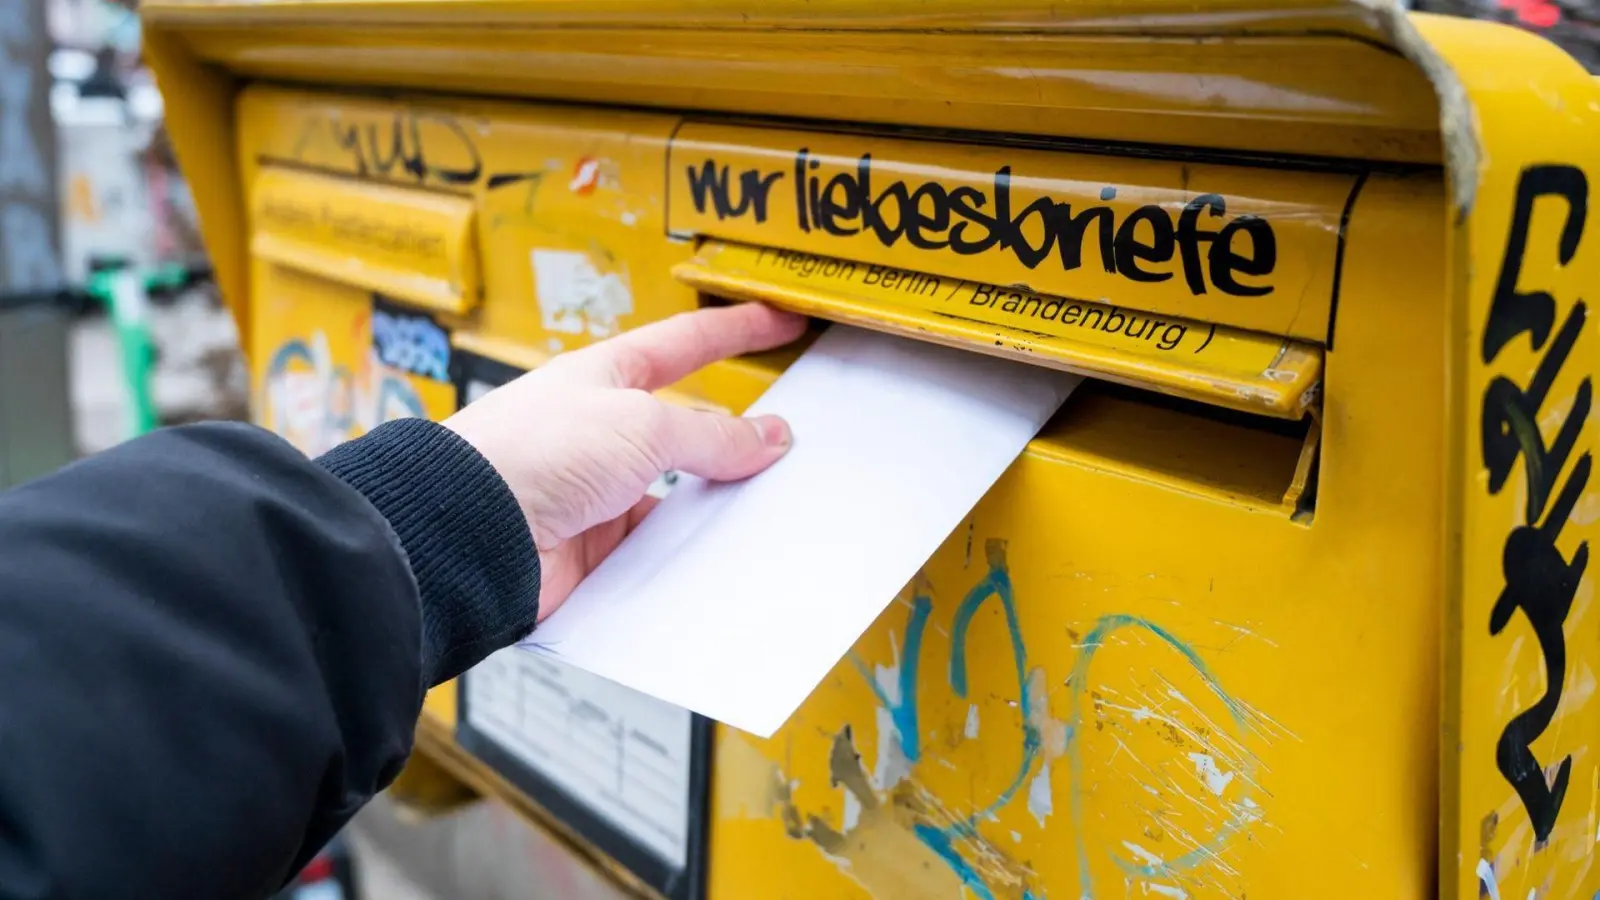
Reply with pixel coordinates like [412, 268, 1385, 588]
[573, 303, 805, 391]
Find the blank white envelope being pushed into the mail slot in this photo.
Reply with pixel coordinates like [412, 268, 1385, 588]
[522, 325, 1080, 737]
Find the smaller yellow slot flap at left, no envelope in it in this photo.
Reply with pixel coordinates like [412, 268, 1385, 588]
[251, 168, 482, 315]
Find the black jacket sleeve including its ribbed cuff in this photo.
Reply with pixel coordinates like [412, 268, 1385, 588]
[0, 420, 539, 900]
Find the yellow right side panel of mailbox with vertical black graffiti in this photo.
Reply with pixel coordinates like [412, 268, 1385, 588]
[1419, 19, 1600, 900]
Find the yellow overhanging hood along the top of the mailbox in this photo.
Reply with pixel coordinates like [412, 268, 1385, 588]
[152, 0, 1445, 349]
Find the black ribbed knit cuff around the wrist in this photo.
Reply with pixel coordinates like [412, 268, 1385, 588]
[317, 418, 539, 687]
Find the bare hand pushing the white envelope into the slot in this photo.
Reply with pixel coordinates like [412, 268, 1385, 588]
[443, 303, 805, 620]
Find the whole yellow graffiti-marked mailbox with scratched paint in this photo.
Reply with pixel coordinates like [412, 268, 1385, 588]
[144, 0, 1600, 900]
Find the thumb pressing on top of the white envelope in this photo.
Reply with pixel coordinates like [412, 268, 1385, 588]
[654, 405, 794, 480]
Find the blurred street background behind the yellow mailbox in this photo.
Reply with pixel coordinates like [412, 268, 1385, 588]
[12, 0, 1600, 900]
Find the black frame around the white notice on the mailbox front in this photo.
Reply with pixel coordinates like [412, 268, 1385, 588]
[451, 348, 714, 900]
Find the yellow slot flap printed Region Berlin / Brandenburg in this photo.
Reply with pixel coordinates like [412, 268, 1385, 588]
[674, 240, 1322, 420]
